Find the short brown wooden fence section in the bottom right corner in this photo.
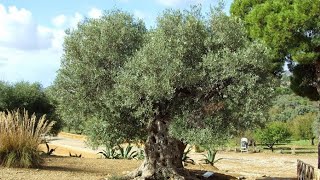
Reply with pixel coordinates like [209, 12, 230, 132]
[297, 159, 319, 180]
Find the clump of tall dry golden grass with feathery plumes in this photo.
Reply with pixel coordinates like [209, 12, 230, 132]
[0, 110, 54, 168]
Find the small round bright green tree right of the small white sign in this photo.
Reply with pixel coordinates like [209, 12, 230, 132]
[255, 121, 291, 152]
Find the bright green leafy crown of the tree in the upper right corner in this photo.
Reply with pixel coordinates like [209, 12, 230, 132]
[231, 0, 320, 100]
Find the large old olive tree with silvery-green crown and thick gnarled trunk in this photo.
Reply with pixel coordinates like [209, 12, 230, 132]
[55, 8, 273, 179]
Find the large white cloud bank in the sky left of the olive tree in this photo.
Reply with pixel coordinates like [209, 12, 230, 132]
[0, 4, 109, 87]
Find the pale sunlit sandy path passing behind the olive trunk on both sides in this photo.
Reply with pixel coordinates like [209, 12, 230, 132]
[42, 134, 317, 179]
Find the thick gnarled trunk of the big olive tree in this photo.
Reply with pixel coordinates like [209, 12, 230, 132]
[129, 119, 186, 180]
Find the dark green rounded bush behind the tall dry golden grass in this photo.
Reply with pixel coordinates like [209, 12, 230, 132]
[0, 81, 62, 134]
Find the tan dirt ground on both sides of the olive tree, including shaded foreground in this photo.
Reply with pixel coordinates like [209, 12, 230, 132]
[0, 133, 317, 180]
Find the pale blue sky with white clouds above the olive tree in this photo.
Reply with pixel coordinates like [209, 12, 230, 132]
[0, 0, 232, 87]
